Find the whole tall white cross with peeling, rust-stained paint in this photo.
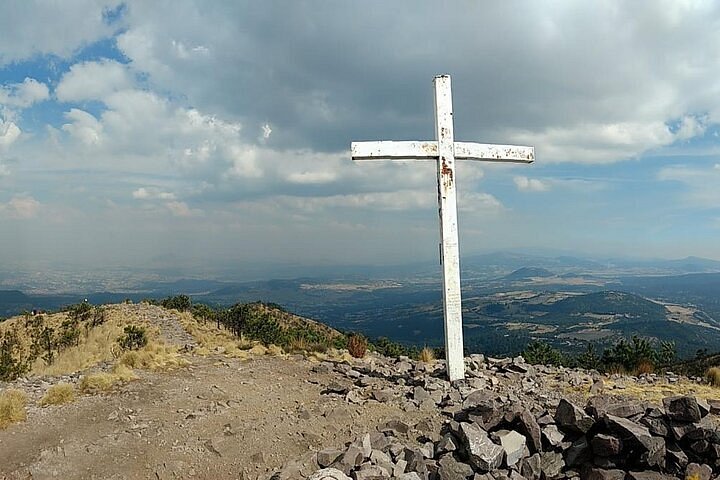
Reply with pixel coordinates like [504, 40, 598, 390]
[351, 75, 535, 381]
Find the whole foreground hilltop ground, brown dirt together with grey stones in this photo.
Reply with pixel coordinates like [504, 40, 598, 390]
[0, 305, 720, 480]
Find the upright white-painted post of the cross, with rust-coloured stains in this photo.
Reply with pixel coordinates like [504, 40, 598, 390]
[433, 75, 465, 382]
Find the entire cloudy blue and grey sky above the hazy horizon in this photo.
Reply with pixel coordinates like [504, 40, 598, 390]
[0, 0, 720, 269]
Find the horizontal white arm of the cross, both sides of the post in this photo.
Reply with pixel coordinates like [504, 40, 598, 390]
[350, 141, 535, 163]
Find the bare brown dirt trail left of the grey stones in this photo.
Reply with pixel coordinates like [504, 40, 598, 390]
[0, 305, 437, 479]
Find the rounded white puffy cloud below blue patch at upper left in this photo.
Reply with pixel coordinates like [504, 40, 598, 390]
[55, 59, 135, 102]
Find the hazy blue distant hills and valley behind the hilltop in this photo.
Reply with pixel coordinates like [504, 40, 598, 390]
[0, 252, 720, 355]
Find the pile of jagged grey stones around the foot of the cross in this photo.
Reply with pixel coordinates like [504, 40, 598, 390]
[298, 356, 720, 480]
